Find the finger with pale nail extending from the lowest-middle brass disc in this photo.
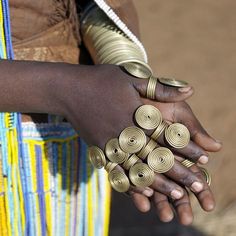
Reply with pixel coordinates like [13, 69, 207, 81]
[150, 171, 184, 199]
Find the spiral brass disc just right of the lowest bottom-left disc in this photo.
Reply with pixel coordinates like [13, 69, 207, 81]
[129, 163, 155, 187]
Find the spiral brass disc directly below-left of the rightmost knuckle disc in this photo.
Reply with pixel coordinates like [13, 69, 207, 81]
[147, 147, 175, 173]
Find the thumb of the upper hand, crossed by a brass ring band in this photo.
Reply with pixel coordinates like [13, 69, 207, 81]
[134, 78, 193, 102]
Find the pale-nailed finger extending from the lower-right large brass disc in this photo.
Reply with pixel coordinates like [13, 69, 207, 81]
[165, 160, 204, 193]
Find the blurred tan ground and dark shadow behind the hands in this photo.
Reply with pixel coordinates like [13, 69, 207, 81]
[110, 0, 236, 236]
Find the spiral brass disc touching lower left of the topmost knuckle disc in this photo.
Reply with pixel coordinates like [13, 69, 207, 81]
[119, 126, 146, 154]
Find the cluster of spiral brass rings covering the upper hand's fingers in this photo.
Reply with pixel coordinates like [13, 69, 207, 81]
[88, 105, 194, 192]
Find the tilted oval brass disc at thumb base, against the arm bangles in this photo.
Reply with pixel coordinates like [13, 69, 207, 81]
[123, 63, 152, 79]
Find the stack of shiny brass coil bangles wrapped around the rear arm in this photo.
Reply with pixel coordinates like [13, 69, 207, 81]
[81, 5, 152, 78]
